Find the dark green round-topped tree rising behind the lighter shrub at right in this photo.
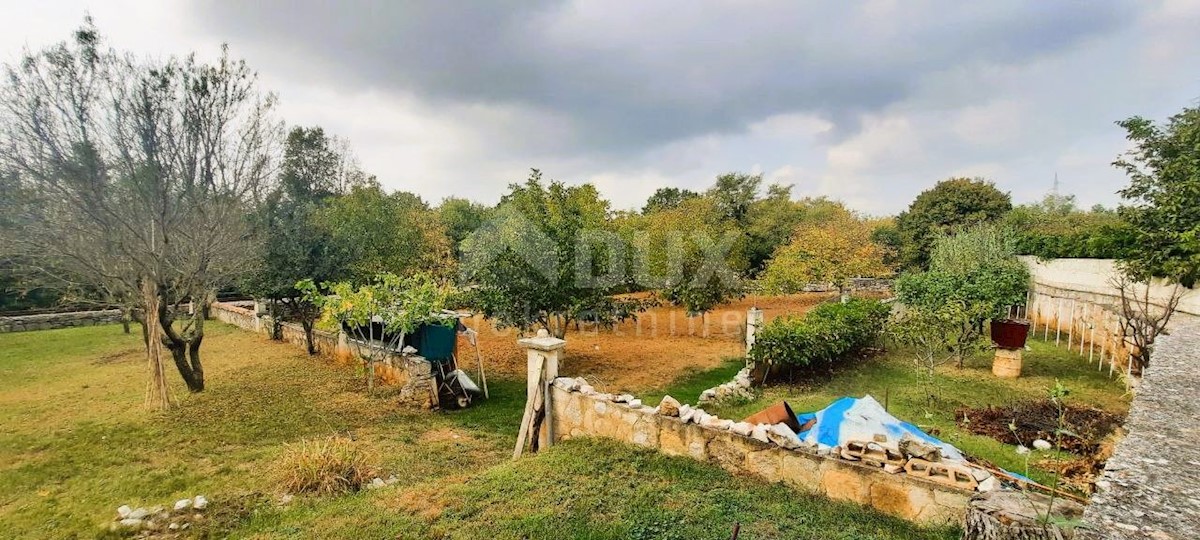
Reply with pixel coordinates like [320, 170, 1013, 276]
[893, 178, 1013, 270]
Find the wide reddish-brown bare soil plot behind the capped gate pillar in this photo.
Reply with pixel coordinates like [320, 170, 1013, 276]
[458, 293, 835, 394]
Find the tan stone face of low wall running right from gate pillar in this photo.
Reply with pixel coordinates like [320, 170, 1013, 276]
[551, 378, 973, 523]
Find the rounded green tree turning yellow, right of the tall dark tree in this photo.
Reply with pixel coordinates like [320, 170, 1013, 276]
[318, 180, 454, 281]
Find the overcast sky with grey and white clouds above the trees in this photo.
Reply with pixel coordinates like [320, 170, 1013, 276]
[0, 0, 1200, 214]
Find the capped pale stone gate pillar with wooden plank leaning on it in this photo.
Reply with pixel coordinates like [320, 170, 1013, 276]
[512, 329, 566, 458]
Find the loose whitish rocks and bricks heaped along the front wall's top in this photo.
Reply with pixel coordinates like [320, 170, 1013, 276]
[554, 368, 1001, 491]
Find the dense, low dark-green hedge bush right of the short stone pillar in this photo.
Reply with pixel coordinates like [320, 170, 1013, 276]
[750, 299, 889, 367]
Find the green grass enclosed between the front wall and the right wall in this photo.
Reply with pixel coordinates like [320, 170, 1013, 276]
[672, 340, 1130, 481]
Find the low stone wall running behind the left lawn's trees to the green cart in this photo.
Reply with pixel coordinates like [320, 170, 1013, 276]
[209, 302, 438, 409]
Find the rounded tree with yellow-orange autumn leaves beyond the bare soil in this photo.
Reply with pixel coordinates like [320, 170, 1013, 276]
[763, 208, 890, 295]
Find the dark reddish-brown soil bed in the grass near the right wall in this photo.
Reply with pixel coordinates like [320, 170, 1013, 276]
[954, 401, 1124, 456]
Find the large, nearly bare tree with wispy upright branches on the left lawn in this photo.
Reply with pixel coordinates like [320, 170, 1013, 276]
[0, 20, 280, 408]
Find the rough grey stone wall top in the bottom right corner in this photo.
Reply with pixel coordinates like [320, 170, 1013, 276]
[1076, 317, 1200, 540]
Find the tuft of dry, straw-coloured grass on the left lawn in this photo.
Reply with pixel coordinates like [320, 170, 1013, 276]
[277, 437, 379, 494]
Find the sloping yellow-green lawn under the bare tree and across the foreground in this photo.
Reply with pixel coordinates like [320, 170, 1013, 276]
[0, 323, 958, 539]
